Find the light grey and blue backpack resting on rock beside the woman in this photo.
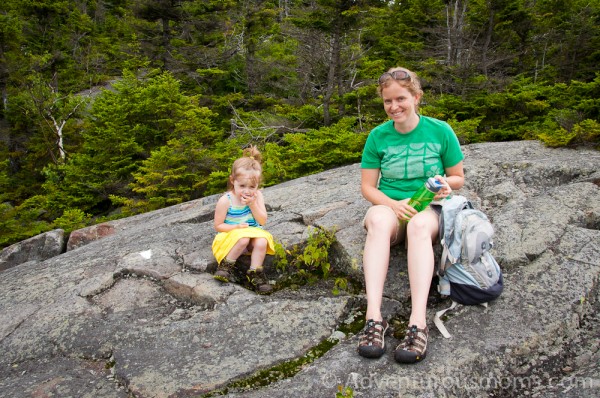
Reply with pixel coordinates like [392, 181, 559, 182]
[434, 195, 504, 338]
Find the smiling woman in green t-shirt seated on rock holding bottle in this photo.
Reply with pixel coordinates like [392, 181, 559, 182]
[358, 68, 464, 363]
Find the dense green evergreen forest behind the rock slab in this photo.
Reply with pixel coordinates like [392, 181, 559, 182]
[0, 0, 600, 248]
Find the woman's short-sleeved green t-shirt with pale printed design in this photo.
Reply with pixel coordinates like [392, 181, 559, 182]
[361, 116, 464, 200]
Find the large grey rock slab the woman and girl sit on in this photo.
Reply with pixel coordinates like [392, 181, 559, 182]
[0, 141, 600, 398]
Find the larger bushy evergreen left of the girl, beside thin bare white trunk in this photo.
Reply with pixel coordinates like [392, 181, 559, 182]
[46, 72, 212, 214]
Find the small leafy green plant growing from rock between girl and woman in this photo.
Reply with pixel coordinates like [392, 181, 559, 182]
[274, 228, 335, 287]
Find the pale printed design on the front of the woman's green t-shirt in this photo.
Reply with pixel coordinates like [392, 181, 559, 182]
[381, 143, 443, 180]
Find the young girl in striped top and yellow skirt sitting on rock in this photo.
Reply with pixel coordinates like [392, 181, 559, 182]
[212, 146, 275, 294]
